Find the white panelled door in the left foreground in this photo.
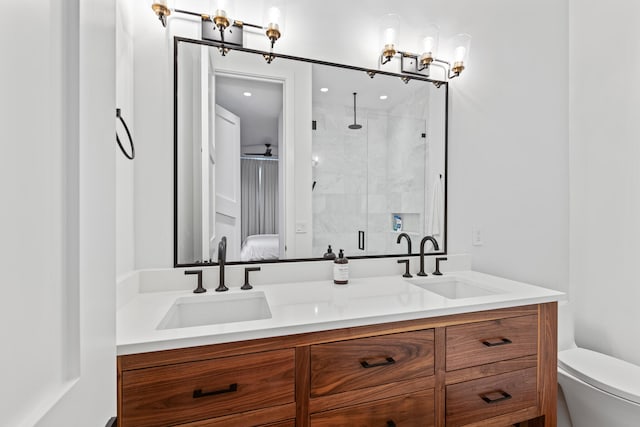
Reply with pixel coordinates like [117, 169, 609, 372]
[0, 0, 116, 427]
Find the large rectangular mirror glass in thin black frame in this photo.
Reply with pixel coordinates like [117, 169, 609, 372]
[174, 38, 448, 266]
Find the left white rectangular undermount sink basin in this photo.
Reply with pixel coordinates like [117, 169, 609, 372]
[158, 292, 271, 329]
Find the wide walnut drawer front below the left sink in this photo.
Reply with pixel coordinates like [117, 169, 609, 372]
[122, 349, 295, 427]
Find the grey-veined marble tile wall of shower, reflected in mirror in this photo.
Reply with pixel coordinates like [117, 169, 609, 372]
[312, 88, 429, 256]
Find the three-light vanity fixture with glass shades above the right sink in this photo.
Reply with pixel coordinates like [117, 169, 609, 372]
[378, 13, 471, 83]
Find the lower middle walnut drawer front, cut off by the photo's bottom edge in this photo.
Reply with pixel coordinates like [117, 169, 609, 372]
[311, 390, 435, 427]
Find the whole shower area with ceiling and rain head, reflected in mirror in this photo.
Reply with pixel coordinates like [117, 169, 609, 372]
[313, 65, 444, 256]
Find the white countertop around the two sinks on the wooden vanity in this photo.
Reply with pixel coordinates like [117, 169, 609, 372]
[116, 271, 564, 355]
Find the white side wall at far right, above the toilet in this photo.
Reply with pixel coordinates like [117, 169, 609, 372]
[570, 0, 640, 365]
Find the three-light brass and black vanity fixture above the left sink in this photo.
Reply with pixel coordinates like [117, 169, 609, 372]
[151, 0, 285, 63]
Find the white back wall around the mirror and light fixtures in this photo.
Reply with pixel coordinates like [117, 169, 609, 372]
[127, 0, 569, 290]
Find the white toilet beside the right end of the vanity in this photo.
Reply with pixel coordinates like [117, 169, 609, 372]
[558, 302, 640, 427]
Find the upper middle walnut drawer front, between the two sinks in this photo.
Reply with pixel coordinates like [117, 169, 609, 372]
[311, 329, 434, 397]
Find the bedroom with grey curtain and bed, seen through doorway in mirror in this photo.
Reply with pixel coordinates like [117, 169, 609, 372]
[214, 74, 283, 261]
